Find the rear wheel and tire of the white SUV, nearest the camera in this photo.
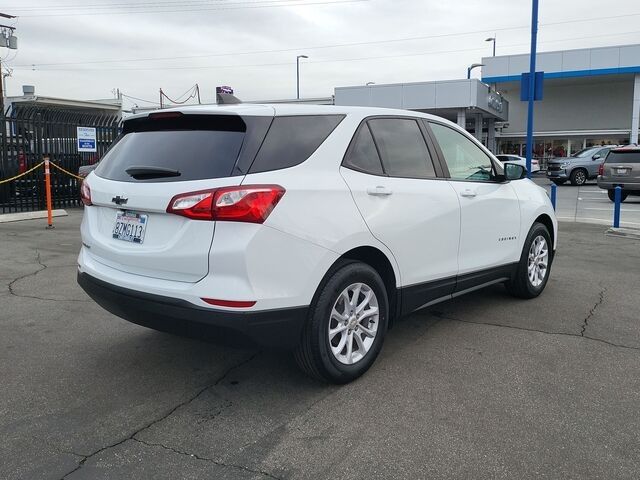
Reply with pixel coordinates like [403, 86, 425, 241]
[294, 261, 389, 384]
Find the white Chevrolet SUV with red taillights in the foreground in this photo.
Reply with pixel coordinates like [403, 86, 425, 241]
[78, 104, 557, 383]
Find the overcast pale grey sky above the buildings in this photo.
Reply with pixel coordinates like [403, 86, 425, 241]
[0, 0, 640, 106]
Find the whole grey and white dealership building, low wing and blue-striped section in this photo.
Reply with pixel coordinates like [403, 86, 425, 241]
[335, 45, 640, 159]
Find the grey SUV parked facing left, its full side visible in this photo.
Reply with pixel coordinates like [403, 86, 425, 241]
[547, 145, 617, 185]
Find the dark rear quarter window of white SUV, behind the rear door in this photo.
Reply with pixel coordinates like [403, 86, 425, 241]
[249, 115, 344, 173]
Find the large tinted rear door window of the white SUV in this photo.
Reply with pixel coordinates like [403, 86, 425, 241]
[369, 118, 435, 178]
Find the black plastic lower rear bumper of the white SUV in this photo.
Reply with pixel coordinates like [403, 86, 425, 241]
[78, 272, 308, 349]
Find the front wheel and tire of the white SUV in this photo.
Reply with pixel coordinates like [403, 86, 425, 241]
[506, 222, 553, 298]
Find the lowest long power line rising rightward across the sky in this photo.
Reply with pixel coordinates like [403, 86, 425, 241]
[16, 31, 640, 72]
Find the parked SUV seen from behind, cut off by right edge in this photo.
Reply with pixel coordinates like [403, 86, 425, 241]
[598, 145, 640, 202]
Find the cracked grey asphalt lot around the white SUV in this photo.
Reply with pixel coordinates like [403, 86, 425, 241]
[0, 211, 640, 479]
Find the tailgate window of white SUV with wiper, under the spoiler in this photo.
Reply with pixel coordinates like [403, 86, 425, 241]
[96, 115, 246, 182]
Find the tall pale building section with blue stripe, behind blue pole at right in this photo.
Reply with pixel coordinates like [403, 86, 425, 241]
[482, 45, 640, 159]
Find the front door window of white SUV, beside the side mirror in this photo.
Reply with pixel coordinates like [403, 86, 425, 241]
[429, 123, 493, 182]
